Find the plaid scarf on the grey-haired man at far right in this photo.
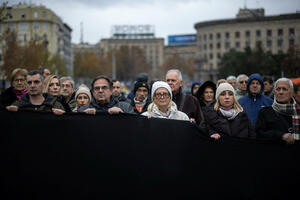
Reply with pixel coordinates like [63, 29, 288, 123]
[272, 98, 300, 140]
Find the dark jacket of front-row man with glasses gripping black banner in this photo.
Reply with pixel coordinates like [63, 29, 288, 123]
[78, 96, 134, 114]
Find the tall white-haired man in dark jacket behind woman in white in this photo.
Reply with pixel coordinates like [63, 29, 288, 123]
[166, 69, 203, 125]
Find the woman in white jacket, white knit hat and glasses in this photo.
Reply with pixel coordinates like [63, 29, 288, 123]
[142, 81, 189, 121]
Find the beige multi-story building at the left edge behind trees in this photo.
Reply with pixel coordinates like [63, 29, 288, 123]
[0, 3, 73, 75]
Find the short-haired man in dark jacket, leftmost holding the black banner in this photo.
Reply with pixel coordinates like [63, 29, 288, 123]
[6, 70, 65, 115]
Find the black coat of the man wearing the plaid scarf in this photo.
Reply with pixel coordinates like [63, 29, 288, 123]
[255, 106, 293, 139]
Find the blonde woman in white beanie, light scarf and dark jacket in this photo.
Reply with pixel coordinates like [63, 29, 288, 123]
[204, 83, 256, 140]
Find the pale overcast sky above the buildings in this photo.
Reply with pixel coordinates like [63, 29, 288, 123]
[4, 0, 300, 44]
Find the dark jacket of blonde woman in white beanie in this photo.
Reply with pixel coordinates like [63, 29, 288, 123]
[204, 108, 256, 138]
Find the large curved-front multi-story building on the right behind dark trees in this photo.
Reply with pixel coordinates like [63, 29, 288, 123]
[194, 9, 300, 81]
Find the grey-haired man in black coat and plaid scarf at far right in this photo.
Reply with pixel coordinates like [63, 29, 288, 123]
[255, 78, 300, 144]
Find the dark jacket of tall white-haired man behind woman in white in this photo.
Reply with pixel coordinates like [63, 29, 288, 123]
[172, 90, 203, 125]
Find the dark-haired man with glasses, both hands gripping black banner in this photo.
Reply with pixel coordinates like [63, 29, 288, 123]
[78, 76, 134, 114]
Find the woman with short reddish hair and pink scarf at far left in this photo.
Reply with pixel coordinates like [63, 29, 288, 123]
[0, 68, 28, 107]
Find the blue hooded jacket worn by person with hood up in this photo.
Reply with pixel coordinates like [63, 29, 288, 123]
[238, 74, 273, 124]
